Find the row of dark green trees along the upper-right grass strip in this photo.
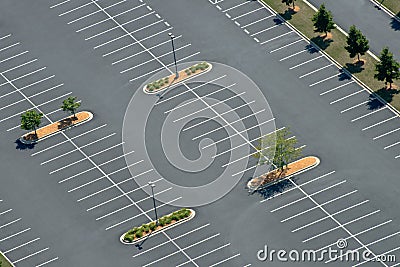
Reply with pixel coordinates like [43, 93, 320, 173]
[282, 0, 400, 89]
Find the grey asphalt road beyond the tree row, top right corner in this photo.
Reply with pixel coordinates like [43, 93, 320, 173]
[309, 0, 400, 60]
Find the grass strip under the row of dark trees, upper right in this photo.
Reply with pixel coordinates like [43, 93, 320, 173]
[262, 0, 400, 110]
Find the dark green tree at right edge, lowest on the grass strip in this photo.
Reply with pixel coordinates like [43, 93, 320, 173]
[374, 47, 400, 89]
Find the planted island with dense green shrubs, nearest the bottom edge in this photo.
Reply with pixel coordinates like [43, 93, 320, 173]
[120, 208, 195, 244]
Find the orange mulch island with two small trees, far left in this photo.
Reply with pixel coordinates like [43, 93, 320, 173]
[23, 111, 90, 141]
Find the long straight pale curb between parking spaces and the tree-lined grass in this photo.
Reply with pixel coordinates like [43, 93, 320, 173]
[257, 0, 400, 117]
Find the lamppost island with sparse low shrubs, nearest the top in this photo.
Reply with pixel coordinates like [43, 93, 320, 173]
[143, 62, 212, 94]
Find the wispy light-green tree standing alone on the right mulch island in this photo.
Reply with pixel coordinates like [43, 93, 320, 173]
[254, 128, 302, 171]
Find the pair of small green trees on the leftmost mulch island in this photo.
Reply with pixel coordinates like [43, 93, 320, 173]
[21, 96, 81, 135]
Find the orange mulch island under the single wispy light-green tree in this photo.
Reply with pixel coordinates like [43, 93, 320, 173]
[247, 156, 320, 189]
